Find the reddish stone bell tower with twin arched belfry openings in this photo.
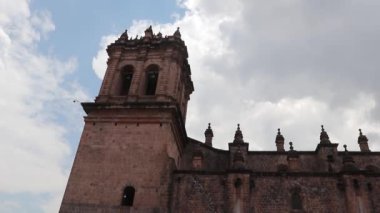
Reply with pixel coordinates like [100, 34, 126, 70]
[60, 27, 194, 212]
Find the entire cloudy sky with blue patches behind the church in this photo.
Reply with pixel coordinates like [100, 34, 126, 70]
[0, 0, 380, 212]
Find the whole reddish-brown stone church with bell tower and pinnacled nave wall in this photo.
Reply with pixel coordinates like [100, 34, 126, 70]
[60, 27, 380, 213]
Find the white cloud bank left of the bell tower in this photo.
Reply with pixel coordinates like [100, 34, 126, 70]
[0, 0, 86, 212]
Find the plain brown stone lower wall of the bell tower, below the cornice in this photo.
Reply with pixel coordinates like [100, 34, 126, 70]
[61, 111, 179, 212]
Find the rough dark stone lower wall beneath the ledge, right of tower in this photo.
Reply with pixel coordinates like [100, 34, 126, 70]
[171, 171, 380, 213]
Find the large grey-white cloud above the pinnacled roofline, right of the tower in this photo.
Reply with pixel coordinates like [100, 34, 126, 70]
[91, 0, 380, 153]
